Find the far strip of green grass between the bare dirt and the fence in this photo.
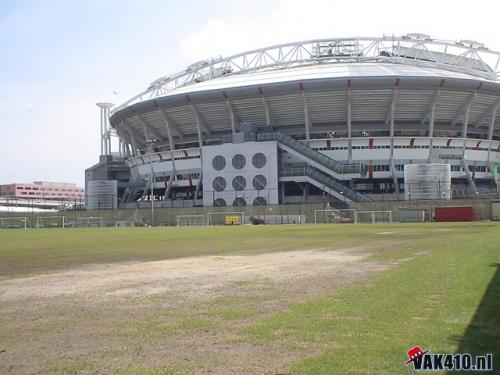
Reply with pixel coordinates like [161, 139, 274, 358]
[0, 224, 472, 279]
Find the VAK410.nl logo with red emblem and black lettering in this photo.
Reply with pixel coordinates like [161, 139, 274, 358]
[404, 346, 493, 371]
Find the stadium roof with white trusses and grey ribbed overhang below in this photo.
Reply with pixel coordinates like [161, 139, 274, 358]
[110, 34, 500, 147]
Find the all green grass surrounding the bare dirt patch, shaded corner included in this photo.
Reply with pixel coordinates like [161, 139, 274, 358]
[0, 223, 500, 374]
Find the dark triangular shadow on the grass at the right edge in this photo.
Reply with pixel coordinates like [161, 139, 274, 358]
[449, 263, 500, 374]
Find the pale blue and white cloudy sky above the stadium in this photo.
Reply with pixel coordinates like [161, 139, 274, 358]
[0, 0, 500, 186]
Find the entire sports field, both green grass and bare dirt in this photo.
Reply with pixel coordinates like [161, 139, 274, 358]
[0, 223, 500, 374]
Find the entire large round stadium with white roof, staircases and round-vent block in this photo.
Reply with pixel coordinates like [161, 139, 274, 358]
[86, 34, 500, 208]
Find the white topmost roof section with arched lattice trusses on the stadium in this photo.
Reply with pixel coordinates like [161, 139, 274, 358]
[111, 33, 500, 114]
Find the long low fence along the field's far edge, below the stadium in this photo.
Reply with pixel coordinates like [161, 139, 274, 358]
[0, 197, 500, 228]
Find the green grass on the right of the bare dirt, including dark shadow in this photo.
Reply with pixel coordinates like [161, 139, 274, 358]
[243, 224, 500, 374]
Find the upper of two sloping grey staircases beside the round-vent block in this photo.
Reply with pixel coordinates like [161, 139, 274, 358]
[257, 133, 367, 176]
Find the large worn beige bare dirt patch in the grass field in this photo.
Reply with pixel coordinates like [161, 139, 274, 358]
[0, 248, 388, 374]
